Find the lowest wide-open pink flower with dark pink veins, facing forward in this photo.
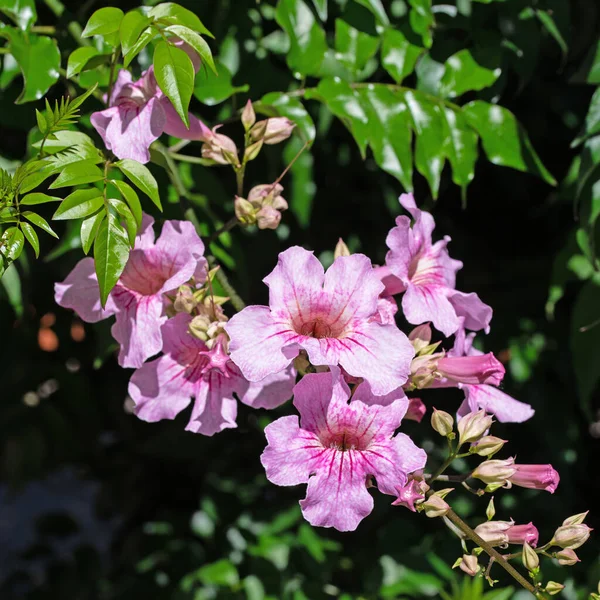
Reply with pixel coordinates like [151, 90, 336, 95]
[261, 368, 426, 531]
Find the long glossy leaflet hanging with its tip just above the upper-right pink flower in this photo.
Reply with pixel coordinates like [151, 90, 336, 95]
[360, 85, 413, 191]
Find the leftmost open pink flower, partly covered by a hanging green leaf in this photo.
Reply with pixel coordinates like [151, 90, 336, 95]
[55, 215, 206, 368]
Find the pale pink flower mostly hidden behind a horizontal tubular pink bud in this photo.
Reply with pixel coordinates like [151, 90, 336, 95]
[450, 328, 535, 423]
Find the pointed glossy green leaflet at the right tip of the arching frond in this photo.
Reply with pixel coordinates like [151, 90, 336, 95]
[463, 100, 556, 185]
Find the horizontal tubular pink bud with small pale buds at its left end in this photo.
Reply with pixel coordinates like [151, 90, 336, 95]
[405, 324, 505, 390]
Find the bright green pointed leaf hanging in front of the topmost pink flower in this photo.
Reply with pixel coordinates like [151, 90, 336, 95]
[153, 41, 196, 127]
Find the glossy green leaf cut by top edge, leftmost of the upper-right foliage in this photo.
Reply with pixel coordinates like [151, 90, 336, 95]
[275, 0, 327, 75]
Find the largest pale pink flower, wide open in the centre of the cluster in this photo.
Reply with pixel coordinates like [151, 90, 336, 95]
[225, 246, 414, 396]
